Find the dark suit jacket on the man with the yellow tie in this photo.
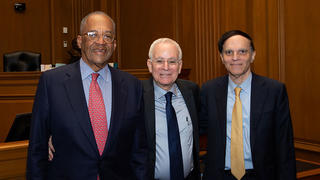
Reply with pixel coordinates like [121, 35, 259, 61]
[200, 74, 296, 180]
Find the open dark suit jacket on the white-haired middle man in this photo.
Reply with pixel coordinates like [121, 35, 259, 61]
[142, 78, 200, 179]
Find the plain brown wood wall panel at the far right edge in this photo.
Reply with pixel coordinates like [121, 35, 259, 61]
[281, 0, 320, 149]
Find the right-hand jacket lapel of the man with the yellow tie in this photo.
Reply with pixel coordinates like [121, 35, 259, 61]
[250, 73, 268, 156]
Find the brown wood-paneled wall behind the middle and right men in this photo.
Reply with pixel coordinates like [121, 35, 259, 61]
[105, 0, 320, 158]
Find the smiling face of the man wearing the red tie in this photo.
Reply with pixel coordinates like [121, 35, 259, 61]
[77, 14, 116, 71]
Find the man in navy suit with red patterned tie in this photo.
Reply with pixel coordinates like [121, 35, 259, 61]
[27, 12, 149, 180]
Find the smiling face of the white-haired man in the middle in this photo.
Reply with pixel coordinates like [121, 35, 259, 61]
[147, 42, 182, 91]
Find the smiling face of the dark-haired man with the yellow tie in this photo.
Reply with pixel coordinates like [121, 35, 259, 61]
[220, 35, 256, 82]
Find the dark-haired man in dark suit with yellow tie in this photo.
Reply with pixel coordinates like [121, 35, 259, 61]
[200, 30, 296, 180]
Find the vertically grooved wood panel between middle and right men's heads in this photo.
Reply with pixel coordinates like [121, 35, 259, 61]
[194, 0, 221, 84]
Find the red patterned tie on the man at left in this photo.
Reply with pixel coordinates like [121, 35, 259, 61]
[89, 73, 108, 156]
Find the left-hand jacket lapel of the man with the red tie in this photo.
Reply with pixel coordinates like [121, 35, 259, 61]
[64, 63, 99, 154]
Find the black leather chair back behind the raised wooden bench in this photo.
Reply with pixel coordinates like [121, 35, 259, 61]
[3, 51, 41, 72]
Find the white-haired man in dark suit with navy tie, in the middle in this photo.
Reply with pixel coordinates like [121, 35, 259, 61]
[143, 38, 200, 180]
